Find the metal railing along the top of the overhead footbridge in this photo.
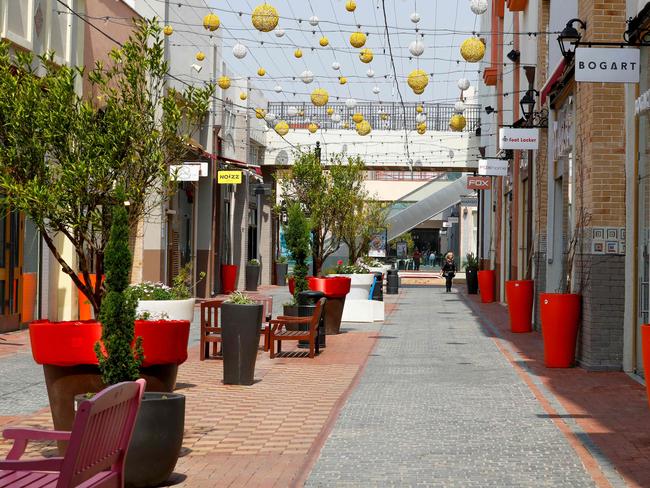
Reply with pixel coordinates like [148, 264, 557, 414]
[268, 102, 481, 132]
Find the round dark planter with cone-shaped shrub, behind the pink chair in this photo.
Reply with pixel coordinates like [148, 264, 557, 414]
[75, 392, 185, 488]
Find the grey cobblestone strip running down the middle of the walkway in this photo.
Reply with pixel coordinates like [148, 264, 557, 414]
[306, 288, 595, 488]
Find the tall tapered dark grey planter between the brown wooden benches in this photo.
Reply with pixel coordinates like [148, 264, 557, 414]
[221, 302, 262, 385]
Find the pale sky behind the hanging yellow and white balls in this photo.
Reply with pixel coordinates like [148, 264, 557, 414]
[167, 0, 480, 107]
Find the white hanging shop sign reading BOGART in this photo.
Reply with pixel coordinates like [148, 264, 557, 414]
[575, 47, 641, 83]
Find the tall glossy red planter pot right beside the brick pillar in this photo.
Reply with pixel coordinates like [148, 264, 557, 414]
[540, 293, 580, 368]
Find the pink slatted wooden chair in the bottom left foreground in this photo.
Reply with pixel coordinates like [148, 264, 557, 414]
[0, 380, 146, 488]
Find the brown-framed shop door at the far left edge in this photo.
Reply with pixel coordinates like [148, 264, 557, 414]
[0, 212, 25, 332]
